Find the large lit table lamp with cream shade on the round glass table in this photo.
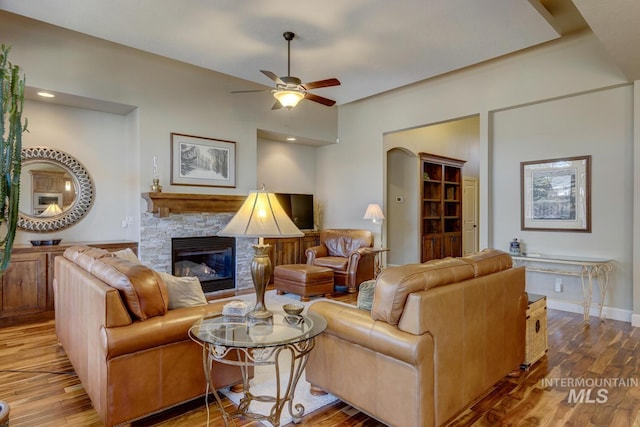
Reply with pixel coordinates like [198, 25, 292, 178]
[218, 190, 304, 320]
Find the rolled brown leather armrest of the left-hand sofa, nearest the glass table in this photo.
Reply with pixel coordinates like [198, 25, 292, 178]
[100, 303, 223, 360]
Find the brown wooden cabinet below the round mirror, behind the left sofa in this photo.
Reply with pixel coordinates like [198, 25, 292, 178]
[0, 242, 138, 326]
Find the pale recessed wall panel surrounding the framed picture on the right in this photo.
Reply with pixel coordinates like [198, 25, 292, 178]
[490, 86, 633, 310]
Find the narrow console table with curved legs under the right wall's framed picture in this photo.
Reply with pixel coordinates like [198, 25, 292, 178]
[512, 255, 613, 322]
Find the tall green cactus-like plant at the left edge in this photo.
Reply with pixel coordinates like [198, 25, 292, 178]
[0, 45, 27, 274]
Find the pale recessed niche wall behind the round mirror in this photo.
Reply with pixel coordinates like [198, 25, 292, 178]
[16, 100, 139, 243]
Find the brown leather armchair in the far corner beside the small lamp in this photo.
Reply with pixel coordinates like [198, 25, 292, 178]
[306, 229, 375, 293]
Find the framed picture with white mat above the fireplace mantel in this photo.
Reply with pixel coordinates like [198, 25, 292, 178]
[171, 133, 236, 187]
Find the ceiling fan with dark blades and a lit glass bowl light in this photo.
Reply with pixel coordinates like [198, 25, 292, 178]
[232, 31, 340, 110]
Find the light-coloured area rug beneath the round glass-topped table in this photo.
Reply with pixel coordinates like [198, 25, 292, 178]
[212, 290, 337, 426]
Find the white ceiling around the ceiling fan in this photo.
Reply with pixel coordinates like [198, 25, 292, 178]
[0, 0, 640, 105]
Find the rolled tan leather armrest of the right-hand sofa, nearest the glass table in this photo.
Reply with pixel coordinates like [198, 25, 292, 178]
[309, 301, 431, 365]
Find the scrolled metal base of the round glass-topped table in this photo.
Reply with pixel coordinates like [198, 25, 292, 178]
[202, 338, 315, 427]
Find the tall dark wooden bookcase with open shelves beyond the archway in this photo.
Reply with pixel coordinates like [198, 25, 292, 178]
[420, 153, 466, 262]
